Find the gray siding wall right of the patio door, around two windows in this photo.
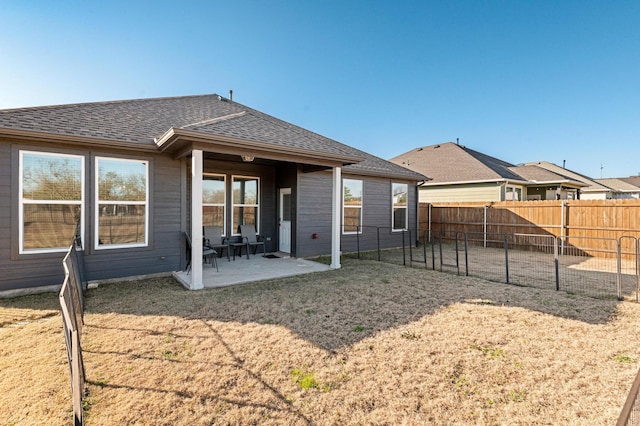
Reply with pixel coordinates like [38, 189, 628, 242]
[297, 172, 417, 257]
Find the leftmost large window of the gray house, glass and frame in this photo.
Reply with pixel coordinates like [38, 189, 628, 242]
[18, 151, 84, 253]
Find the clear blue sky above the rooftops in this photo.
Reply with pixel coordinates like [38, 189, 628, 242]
[0, 0, 640, 178]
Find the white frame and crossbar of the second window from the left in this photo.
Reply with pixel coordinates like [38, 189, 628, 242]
[93, 156, 149, 250]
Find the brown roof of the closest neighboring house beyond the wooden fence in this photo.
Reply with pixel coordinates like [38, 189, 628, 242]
[391, 142, 583, 187]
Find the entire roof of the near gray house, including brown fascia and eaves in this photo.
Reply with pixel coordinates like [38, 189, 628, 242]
[0, 94, 425, 181]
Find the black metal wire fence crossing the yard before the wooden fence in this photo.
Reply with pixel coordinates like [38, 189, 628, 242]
[350, 226, 640, 301]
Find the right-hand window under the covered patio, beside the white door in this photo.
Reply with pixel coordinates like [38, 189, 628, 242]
[231, 176, 260, 235]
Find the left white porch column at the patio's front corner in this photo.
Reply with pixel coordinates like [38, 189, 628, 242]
[189, 149, 204, 290]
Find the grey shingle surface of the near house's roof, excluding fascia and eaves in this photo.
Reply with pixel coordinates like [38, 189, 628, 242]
[0, 94, 424, 181]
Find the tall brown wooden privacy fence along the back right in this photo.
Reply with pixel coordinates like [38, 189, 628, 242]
[418, 199, 640, 258]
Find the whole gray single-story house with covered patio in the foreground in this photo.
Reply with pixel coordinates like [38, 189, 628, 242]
[0, 95, 425, 290]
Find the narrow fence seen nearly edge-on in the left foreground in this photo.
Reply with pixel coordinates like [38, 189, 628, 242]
[59, 241, 86, 426]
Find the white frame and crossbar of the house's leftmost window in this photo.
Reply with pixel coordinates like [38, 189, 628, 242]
[18, 150, 85, 254]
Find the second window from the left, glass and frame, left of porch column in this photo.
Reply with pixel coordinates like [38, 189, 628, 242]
[95, 157, 149, 249]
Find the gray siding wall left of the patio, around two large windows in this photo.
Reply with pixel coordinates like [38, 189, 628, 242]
[0, 141, 184, 291]
